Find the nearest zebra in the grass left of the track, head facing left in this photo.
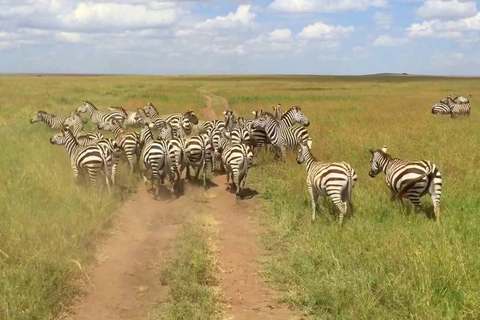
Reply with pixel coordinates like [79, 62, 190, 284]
[50, 128, 110, 188]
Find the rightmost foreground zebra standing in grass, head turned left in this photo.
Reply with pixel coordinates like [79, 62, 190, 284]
[369, 147, 442, 221]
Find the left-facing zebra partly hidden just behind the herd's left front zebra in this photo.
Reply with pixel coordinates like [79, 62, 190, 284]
[97, 122, 141, 173]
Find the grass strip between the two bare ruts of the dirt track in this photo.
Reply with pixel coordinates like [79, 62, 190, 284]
[148, 214, 223, 320]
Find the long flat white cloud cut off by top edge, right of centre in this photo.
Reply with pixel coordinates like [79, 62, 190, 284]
[267, 0, 387, 13]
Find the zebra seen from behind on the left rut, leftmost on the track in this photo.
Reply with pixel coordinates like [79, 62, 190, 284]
[140, 123, 174, 200]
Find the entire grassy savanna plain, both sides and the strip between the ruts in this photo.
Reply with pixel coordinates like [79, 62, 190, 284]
[0, 75, 480, 319]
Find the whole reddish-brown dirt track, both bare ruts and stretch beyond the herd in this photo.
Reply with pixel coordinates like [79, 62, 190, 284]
[67, 88, 300, 320]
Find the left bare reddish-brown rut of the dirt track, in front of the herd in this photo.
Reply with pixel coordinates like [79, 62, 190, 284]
[67, 183, 191, 320]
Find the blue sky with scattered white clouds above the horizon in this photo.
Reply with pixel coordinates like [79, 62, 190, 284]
[0, 0, 480, 75]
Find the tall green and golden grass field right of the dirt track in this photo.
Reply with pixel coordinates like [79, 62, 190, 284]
[212, 78, 480, 319]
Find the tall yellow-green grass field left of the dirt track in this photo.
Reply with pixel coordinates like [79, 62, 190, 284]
[0, 76, 203, 319]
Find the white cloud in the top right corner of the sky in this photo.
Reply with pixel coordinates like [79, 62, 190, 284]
[417, 0, 477, 20]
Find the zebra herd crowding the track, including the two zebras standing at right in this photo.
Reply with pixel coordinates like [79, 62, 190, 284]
[30, 97, 442, 223]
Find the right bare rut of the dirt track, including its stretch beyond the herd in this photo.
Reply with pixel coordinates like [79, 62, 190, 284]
[201, 88, 302, 320]
